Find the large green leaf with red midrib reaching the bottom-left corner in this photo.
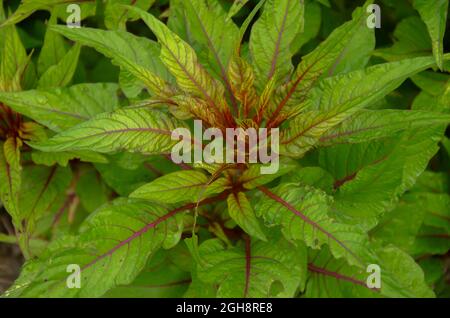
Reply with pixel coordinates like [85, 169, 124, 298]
[5, 199, 181, 297]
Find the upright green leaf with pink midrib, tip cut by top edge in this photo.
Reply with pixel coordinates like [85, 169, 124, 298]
[250, 0, 304, 90]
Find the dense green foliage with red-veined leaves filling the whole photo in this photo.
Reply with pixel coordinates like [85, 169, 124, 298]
[0, 0, 450, 297]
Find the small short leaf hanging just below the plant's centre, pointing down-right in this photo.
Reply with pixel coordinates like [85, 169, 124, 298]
[227, 192, 267, 241]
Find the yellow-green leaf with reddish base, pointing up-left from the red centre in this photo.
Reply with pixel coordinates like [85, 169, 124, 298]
[128, 7, 229, 116]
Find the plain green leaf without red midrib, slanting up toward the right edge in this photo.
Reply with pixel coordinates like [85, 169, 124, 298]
[333, 125, 444, 228]
